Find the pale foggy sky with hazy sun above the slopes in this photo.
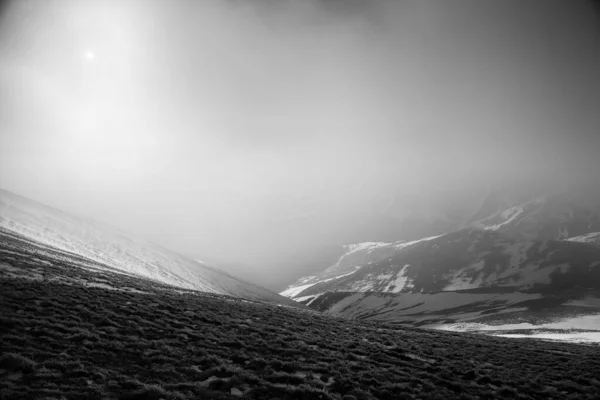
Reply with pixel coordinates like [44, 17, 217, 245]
[0, 0, 600, 288]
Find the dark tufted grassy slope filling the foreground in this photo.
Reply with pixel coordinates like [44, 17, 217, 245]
[0, 241, 600, 400]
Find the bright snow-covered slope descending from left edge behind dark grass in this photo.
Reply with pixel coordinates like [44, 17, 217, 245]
[0, 189, 297, 305]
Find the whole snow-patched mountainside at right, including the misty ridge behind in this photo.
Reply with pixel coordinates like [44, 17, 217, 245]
[281, 187, 600, 323]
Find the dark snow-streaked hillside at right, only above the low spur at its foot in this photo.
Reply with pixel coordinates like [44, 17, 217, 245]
[282, 229, 600, 298]
